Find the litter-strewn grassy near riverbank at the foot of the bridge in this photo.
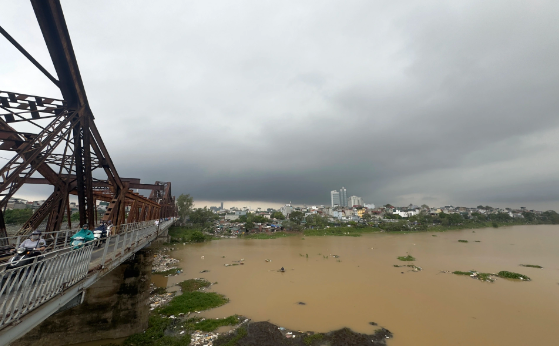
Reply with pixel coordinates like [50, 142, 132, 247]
[121, 248, 392, 346]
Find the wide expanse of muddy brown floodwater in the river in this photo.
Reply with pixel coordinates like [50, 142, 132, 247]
[167, 225, 559, 346]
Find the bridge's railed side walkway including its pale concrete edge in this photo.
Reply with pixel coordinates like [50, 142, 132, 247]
[0, 219, 174, 346]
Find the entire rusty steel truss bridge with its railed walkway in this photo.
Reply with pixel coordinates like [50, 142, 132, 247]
[0, 0, 177, 345]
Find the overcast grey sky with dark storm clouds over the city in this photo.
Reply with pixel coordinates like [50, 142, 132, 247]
[0, 0, 559, 210]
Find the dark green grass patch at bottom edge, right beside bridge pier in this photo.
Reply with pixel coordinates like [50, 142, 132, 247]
[122, 314, 190, 346]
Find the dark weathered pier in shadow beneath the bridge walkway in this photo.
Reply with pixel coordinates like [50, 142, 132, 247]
[11, 249, 153, 346]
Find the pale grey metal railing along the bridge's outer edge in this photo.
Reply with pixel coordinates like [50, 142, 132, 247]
[0, 220, 174, 329]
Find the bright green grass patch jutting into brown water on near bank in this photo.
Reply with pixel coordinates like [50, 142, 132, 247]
[159, 291, 229, 316]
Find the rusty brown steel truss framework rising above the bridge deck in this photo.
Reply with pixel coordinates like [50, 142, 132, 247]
[0, 0, 177, 238]
